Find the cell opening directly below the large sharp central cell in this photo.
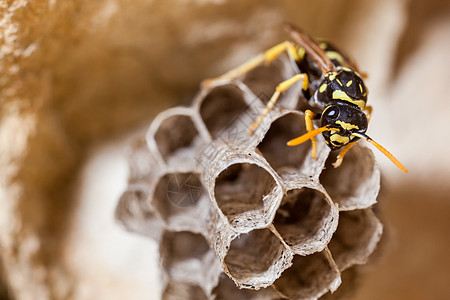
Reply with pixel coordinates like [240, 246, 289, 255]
[224, 229, 286, 282]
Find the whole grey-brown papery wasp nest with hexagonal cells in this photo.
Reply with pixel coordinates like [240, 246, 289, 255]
[117, 57, 382, 299]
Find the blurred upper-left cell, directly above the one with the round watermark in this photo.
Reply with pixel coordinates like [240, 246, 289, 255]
[150, 114, 204, 163]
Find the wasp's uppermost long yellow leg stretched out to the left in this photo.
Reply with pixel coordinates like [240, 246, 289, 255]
[202, 41, 300, 86]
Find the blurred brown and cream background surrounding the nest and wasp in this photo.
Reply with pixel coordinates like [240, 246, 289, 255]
[0, 0, 450, 299]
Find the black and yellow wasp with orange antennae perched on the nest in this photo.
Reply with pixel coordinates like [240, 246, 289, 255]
[203, 24, 408, 173]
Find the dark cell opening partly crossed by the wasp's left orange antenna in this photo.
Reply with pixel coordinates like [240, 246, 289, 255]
[258, 113, 311, 171]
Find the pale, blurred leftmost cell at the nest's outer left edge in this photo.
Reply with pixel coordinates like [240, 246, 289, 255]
[115, 184, 162, 240]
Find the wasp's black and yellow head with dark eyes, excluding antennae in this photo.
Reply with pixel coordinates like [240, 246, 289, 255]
[321, 104, 368, 150]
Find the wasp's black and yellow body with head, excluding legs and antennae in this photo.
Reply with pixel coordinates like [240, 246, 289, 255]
[297, 42, 368, 150]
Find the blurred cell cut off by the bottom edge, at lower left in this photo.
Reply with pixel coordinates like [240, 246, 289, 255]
[161, 281, 208, 300]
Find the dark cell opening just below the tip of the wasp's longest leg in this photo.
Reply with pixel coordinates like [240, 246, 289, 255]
[200, 84, 249, 139]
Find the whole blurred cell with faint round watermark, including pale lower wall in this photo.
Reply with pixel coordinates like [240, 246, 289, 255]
[152, 172, 211, 232]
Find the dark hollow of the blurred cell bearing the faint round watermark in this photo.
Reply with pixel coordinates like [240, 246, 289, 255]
[153, 172, 207, 225]
